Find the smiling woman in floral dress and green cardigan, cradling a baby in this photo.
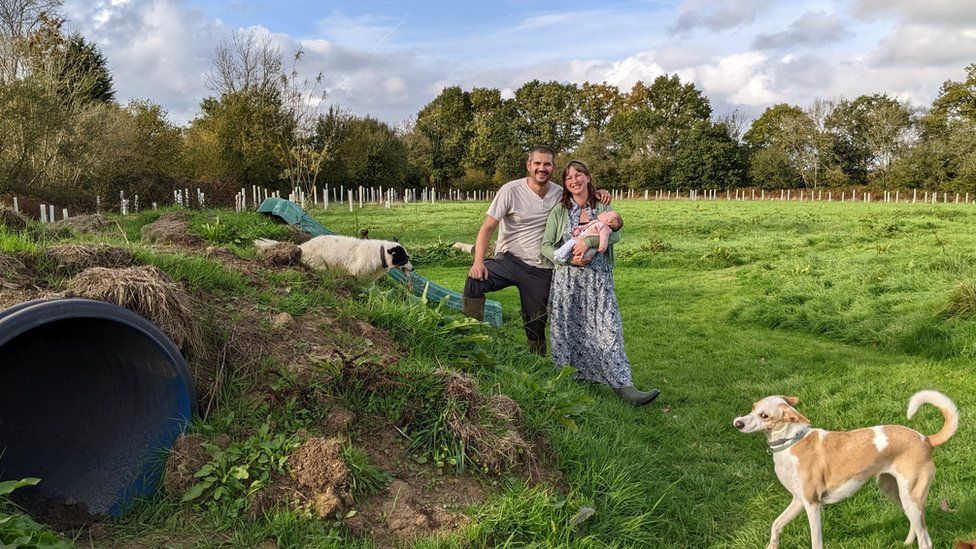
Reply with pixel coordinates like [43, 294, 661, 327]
[542, 160, 660, 406]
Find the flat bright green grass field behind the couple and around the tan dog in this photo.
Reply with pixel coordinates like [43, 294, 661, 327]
[308, 201, 976, 548]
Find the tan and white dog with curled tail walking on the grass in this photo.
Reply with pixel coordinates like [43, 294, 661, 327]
[733, 391, 959, 549]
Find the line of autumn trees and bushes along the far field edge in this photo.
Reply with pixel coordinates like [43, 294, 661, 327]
[0, 0, 976, 207]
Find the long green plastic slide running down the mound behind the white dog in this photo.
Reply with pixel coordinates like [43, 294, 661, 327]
[258, 197, 502, 326]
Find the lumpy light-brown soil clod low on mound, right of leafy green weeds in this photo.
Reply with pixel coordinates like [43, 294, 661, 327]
[288, 437, 350, 519]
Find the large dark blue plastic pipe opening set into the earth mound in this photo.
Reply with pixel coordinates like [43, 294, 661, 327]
[0, 299, 196, 516]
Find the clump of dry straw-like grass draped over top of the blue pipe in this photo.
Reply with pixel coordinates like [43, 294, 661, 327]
[64, 265, 200, 349]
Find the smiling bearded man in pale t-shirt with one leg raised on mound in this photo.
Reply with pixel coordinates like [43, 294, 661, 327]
[461, 146, 610, 355]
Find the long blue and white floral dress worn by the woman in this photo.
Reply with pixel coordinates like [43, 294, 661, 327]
[549, 203, 634, 388]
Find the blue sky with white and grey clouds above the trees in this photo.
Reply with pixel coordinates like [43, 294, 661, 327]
[65, 0, 976, 124]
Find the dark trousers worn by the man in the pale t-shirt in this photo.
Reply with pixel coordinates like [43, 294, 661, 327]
[464, 254, 552, 349]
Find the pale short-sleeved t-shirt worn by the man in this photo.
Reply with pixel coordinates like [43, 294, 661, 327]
[488, 177, 563, 269]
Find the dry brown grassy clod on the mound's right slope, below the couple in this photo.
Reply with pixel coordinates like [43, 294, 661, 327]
[442, 372, 535, 473]
